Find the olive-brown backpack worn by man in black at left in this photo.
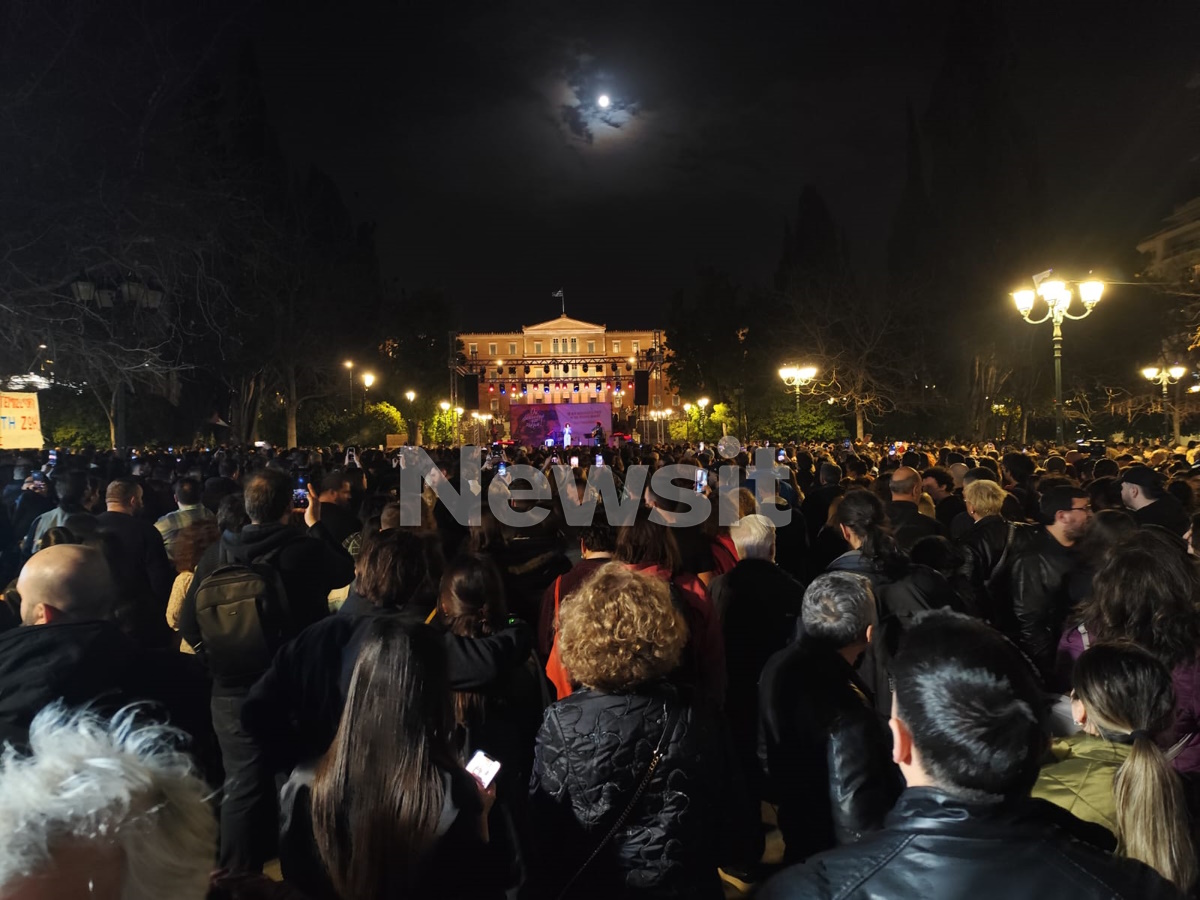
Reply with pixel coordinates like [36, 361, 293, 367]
[196, 546, 289, 682]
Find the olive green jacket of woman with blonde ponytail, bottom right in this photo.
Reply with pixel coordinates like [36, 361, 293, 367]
[1033, 732, 1129, 834]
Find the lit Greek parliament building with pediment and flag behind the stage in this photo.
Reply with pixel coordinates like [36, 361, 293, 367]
[451, 313, 683, 443]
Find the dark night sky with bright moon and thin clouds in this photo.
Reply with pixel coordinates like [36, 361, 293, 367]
[257, 0, 1200, 329]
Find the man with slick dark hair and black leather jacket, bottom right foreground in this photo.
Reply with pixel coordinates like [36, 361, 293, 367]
[756, 612, 1181, 900]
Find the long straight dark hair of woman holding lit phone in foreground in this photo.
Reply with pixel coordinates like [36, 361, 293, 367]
[312, 617, 458, 898]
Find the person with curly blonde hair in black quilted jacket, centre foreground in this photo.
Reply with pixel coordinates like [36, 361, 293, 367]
[529, 563, 763, 900]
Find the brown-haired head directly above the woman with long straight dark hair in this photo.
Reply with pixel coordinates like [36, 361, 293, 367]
[355, 528, 451, 608]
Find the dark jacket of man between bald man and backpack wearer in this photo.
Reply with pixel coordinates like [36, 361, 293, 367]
[96, 512, 178, 647]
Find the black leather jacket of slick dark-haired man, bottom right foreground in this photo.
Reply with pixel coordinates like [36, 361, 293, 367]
[756, 787, 1181, 900]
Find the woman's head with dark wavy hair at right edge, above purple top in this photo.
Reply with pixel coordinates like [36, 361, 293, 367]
[1080, 529, 1200, 668]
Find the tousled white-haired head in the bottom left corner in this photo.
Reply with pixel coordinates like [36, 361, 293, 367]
[0, 707, 217, 900]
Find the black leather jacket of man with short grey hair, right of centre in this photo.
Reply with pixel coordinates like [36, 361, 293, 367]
[760, 637, 902, 862]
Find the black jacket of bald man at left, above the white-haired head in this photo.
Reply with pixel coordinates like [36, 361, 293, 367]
[0, 622, 218, 773]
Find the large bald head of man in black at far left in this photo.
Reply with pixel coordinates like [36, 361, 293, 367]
[17, 544, 115, 625]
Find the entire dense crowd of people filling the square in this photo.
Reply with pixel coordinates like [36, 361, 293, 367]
[0, 434, 1200, 900]
